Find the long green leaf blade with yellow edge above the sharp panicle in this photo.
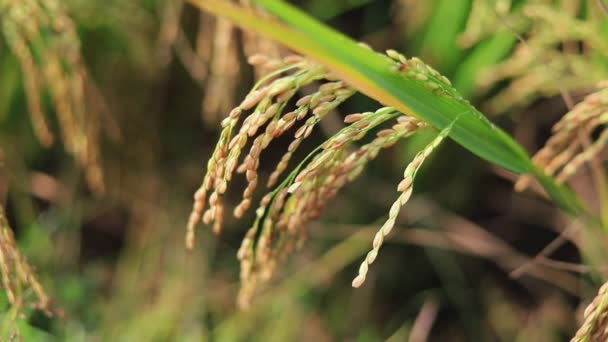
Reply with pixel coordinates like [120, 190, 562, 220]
[190, 0, 581, 214]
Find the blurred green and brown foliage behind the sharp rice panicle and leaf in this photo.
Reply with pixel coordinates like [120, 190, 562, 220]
[0, 0, 608, 341]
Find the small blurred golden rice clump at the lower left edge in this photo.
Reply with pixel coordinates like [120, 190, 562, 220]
[0, 206, 53, 315]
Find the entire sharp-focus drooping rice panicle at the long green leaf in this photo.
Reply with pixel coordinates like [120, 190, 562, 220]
[186, 50, 454, 308]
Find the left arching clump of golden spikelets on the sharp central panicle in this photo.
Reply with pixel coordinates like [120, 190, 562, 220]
[186, 57, 340, 247]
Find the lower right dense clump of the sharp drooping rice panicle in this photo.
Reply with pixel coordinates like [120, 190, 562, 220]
[238, 107, 425, 308]
